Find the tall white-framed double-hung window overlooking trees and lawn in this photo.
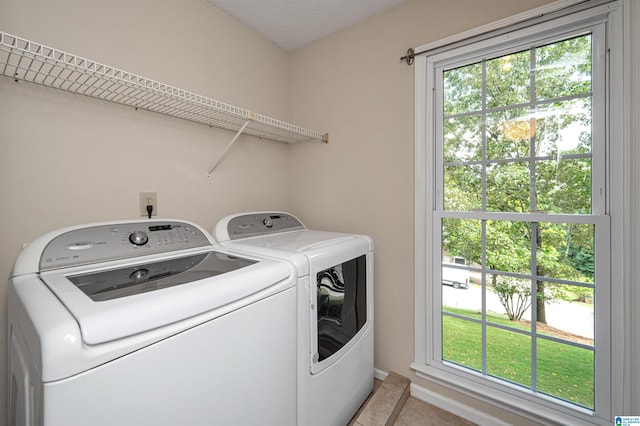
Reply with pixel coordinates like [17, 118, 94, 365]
[414, 2, 615, 422]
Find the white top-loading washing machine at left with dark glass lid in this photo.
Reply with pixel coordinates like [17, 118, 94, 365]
[7, 220, 297, 426]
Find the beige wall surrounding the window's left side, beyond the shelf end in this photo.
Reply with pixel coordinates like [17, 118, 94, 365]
[291, 0, 564, 424]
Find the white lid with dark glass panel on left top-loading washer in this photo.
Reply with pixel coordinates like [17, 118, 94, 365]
[41, 250, 295, 345]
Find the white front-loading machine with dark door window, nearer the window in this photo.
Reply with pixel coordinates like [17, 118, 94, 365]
[215, 212, 374, 426]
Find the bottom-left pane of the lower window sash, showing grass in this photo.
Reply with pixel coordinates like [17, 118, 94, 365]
[442, 315, 482, 371]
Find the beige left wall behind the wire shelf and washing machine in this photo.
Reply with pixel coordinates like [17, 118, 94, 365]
[0, 0, 290, 425]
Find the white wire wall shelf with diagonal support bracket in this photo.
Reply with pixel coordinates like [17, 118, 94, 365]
[0, 31, 329, 173]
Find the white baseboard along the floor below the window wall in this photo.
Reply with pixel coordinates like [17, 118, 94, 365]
[373, 368, 510, 426]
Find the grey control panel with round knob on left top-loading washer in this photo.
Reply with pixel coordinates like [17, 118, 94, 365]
[40, 221, 212, 271]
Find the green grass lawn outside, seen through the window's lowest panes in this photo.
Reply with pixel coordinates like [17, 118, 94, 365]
[442, 308, 594, 408]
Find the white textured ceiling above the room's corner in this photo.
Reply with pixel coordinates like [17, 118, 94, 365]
[209, 0, 406, 51]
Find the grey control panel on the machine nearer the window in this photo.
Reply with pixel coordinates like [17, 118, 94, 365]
[216, 212, 306, 241]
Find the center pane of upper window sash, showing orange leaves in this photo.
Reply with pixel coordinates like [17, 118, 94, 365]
[487, 108, 535, 160]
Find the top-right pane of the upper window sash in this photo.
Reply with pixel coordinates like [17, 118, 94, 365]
[535, 35, 591, 99]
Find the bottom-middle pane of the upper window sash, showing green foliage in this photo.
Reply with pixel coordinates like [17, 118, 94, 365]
[487, 162, 531, 213]
